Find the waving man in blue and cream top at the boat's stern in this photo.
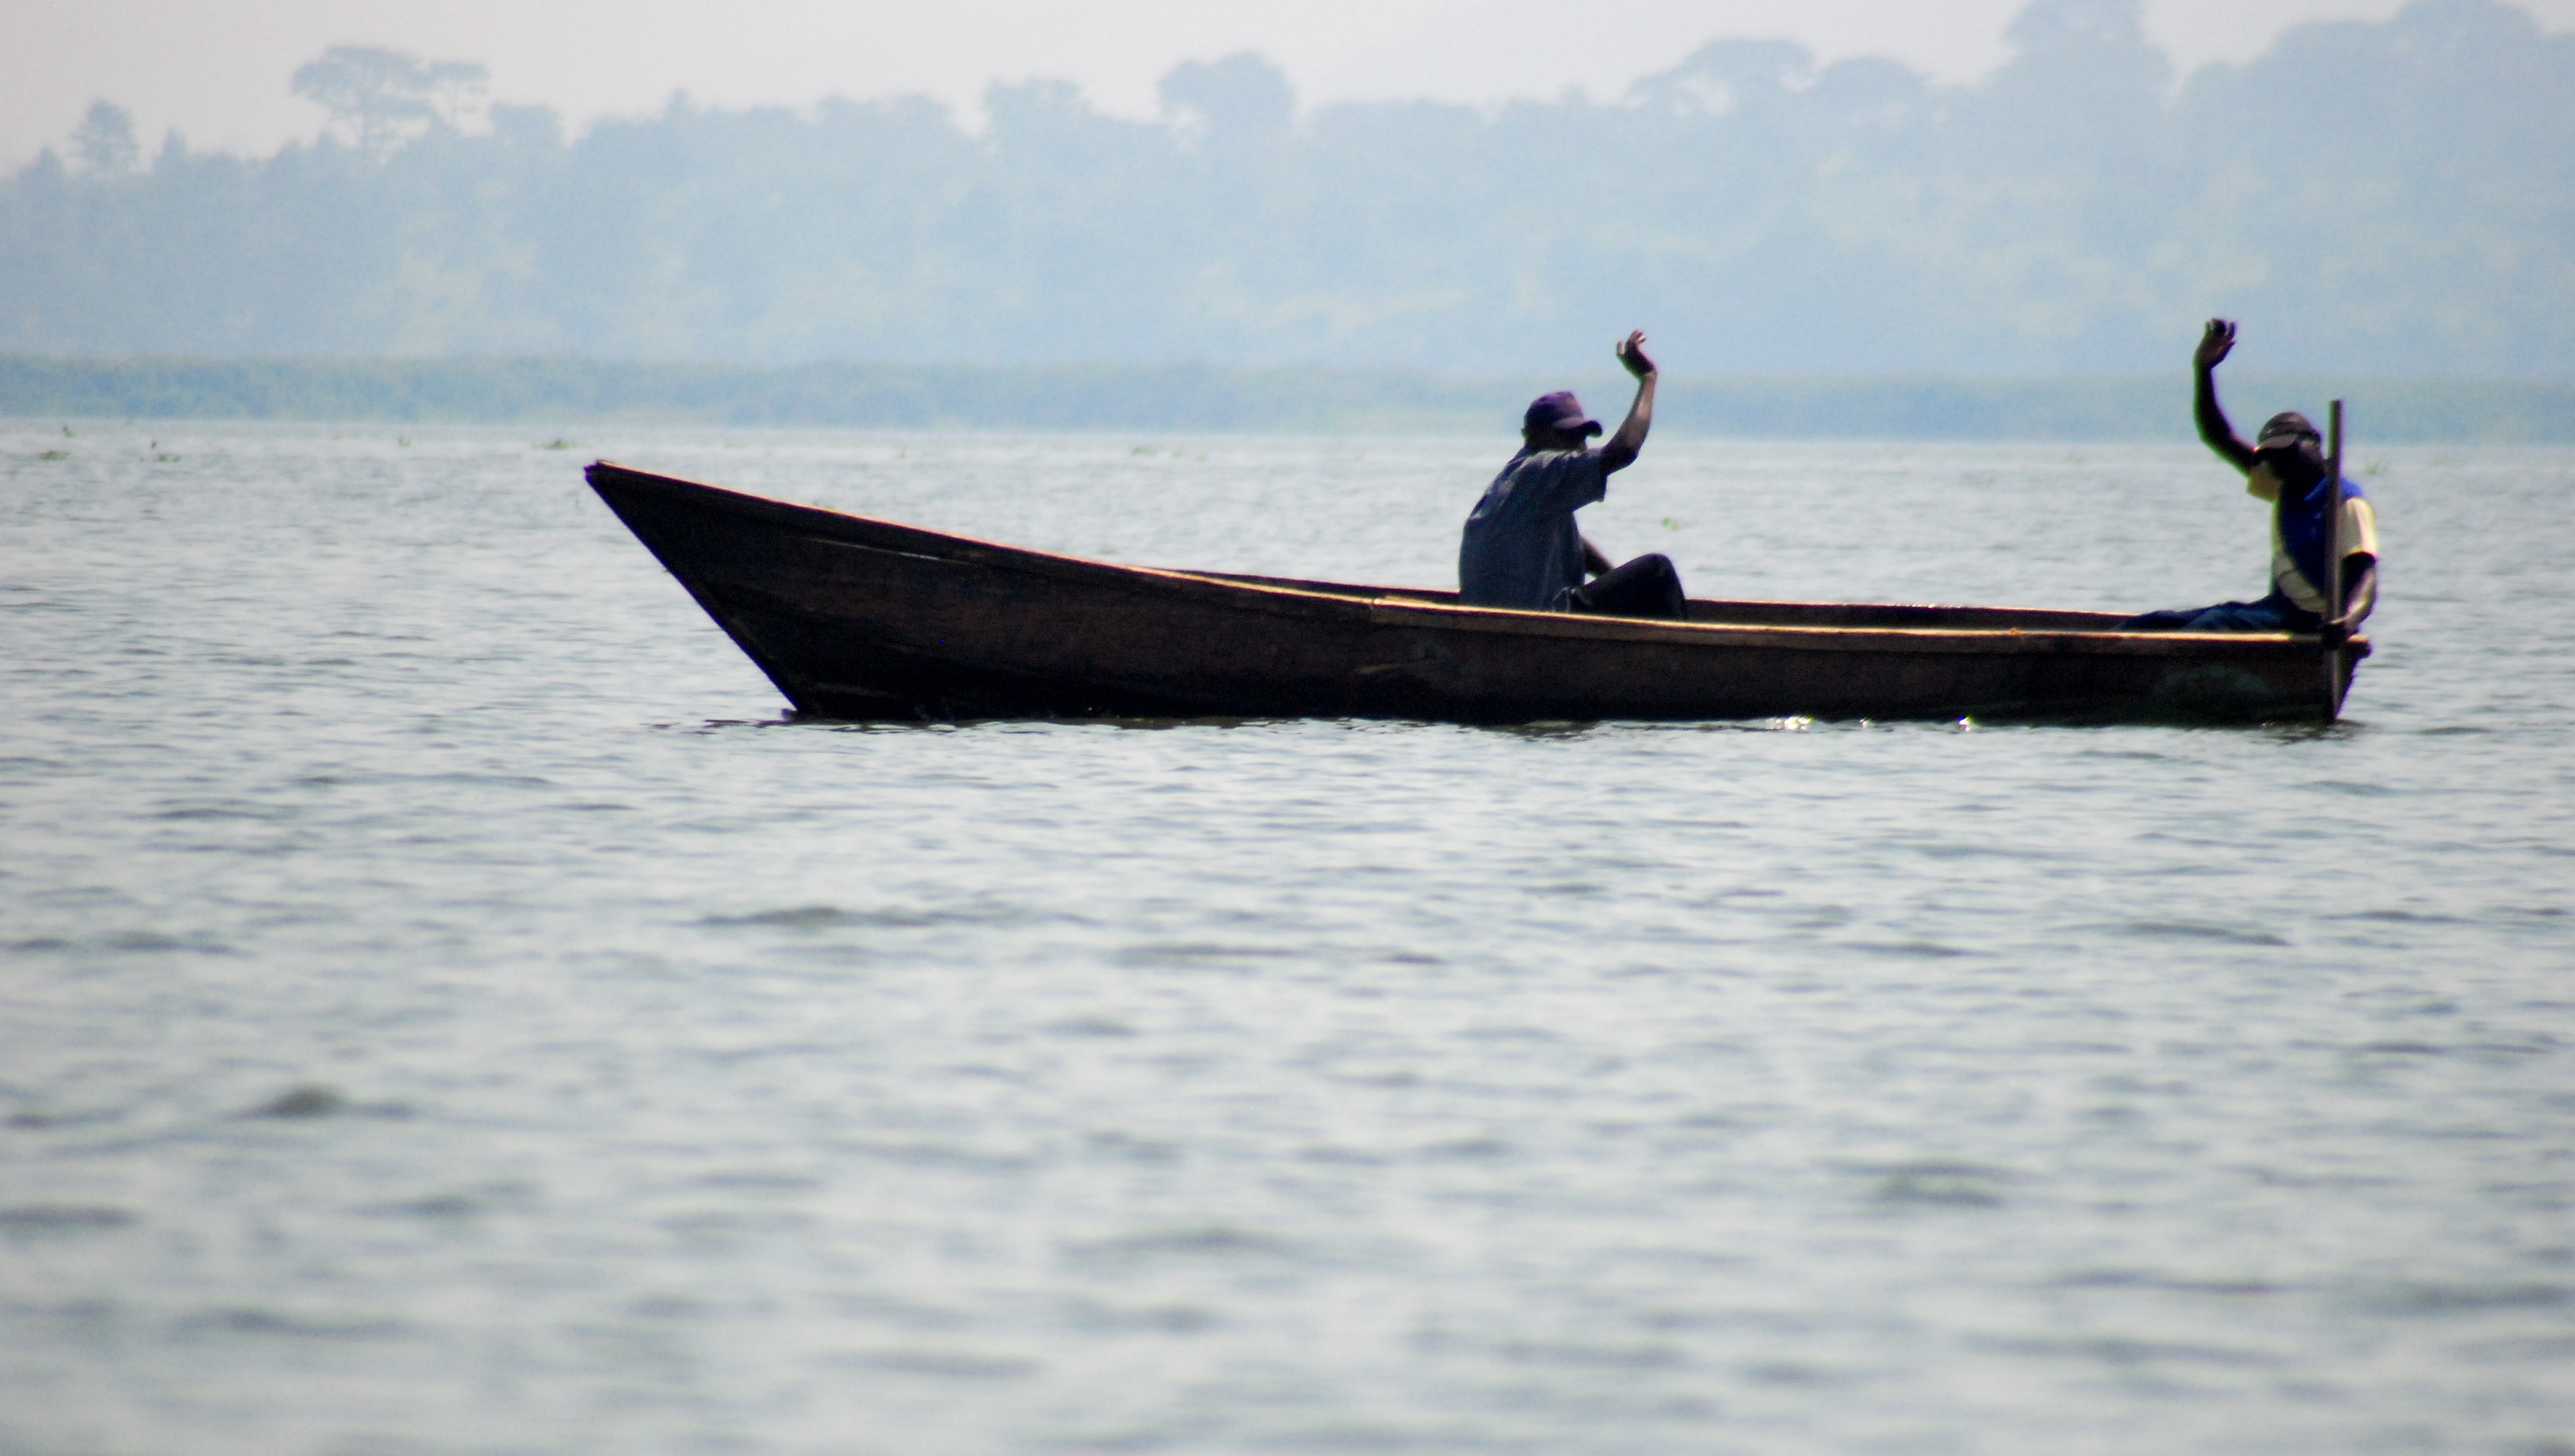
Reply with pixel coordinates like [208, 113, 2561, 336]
[2119, 319, 2379, 647]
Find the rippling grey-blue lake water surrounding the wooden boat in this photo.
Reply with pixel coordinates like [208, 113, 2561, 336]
[0, 405, 2575, 1456]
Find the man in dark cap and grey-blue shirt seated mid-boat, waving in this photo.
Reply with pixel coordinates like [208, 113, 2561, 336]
[1457, 330, 1689, 618]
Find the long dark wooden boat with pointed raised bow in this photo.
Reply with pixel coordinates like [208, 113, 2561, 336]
[590, 462, 2369, 721]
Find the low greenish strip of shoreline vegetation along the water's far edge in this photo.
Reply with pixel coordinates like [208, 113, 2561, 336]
[0, 355, 2575, 443]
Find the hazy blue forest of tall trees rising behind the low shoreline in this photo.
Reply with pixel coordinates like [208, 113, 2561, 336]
[0, 0, 2575, 379]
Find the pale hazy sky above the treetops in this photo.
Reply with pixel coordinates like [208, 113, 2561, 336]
[20, 0, 2575, 168]
